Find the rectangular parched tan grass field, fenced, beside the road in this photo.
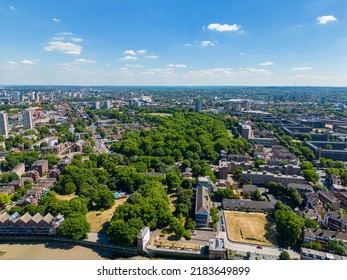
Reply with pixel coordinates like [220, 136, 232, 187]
[224, 211, 276, 245]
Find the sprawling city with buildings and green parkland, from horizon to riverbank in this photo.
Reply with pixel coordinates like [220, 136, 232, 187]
[0, 86, 347, 260]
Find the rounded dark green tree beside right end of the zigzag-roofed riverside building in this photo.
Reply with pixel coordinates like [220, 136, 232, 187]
[59, 214, 90, 240]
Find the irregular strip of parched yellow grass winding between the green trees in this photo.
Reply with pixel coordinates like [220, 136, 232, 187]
[86, 197, 127, 232]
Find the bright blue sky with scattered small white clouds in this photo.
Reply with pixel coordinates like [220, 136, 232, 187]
[0, 0, 347, 86]
